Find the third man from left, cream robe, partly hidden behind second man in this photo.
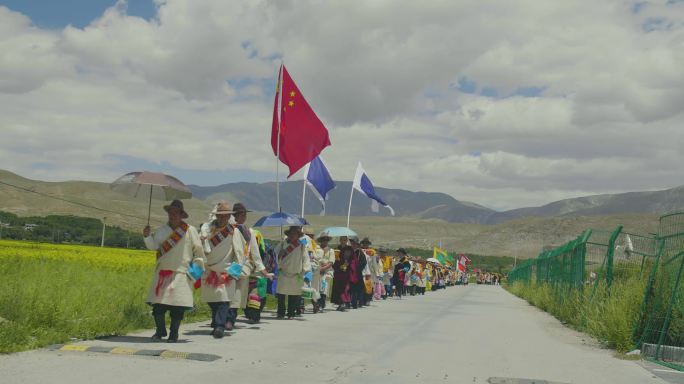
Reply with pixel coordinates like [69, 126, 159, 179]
[229, 203, 273, 329]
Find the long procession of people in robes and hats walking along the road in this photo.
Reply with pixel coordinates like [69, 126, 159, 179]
[143, 200, 468, 342]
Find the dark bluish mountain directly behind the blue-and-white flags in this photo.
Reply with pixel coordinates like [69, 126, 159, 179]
[189, 181, 495, 223]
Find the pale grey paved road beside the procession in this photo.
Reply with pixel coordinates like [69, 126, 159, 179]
[0, 285, 677, 384]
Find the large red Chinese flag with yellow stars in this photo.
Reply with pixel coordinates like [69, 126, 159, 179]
[271, 65, 330, 177]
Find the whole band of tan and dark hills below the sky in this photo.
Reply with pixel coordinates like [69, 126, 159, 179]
[0, 170, 684, 258]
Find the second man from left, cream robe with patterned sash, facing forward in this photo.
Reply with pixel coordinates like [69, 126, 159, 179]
[200, 201, 244, 339]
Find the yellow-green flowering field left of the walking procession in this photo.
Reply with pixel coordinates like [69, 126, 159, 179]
[0, 241, 210, 353]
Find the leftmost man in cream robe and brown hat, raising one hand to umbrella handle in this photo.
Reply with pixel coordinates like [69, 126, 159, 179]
[143, 200, 205, 343]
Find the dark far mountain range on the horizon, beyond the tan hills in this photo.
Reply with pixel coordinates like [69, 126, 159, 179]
[190, 181, 684, 225]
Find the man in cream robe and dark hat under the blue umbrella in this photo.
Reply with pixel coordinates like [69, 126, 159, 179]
[275, 226, 311, 319]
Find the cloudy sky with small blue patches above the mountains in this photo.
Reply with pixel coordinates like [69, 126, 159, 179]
[0, 0, 684, 209]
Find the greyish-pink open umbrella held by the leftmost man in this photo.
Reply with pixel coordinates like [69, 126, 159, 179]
[109, 171, 192, 225]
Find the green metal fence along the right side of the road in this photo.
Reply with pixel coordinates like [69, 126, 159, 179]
[508, 213, 684, 371]
